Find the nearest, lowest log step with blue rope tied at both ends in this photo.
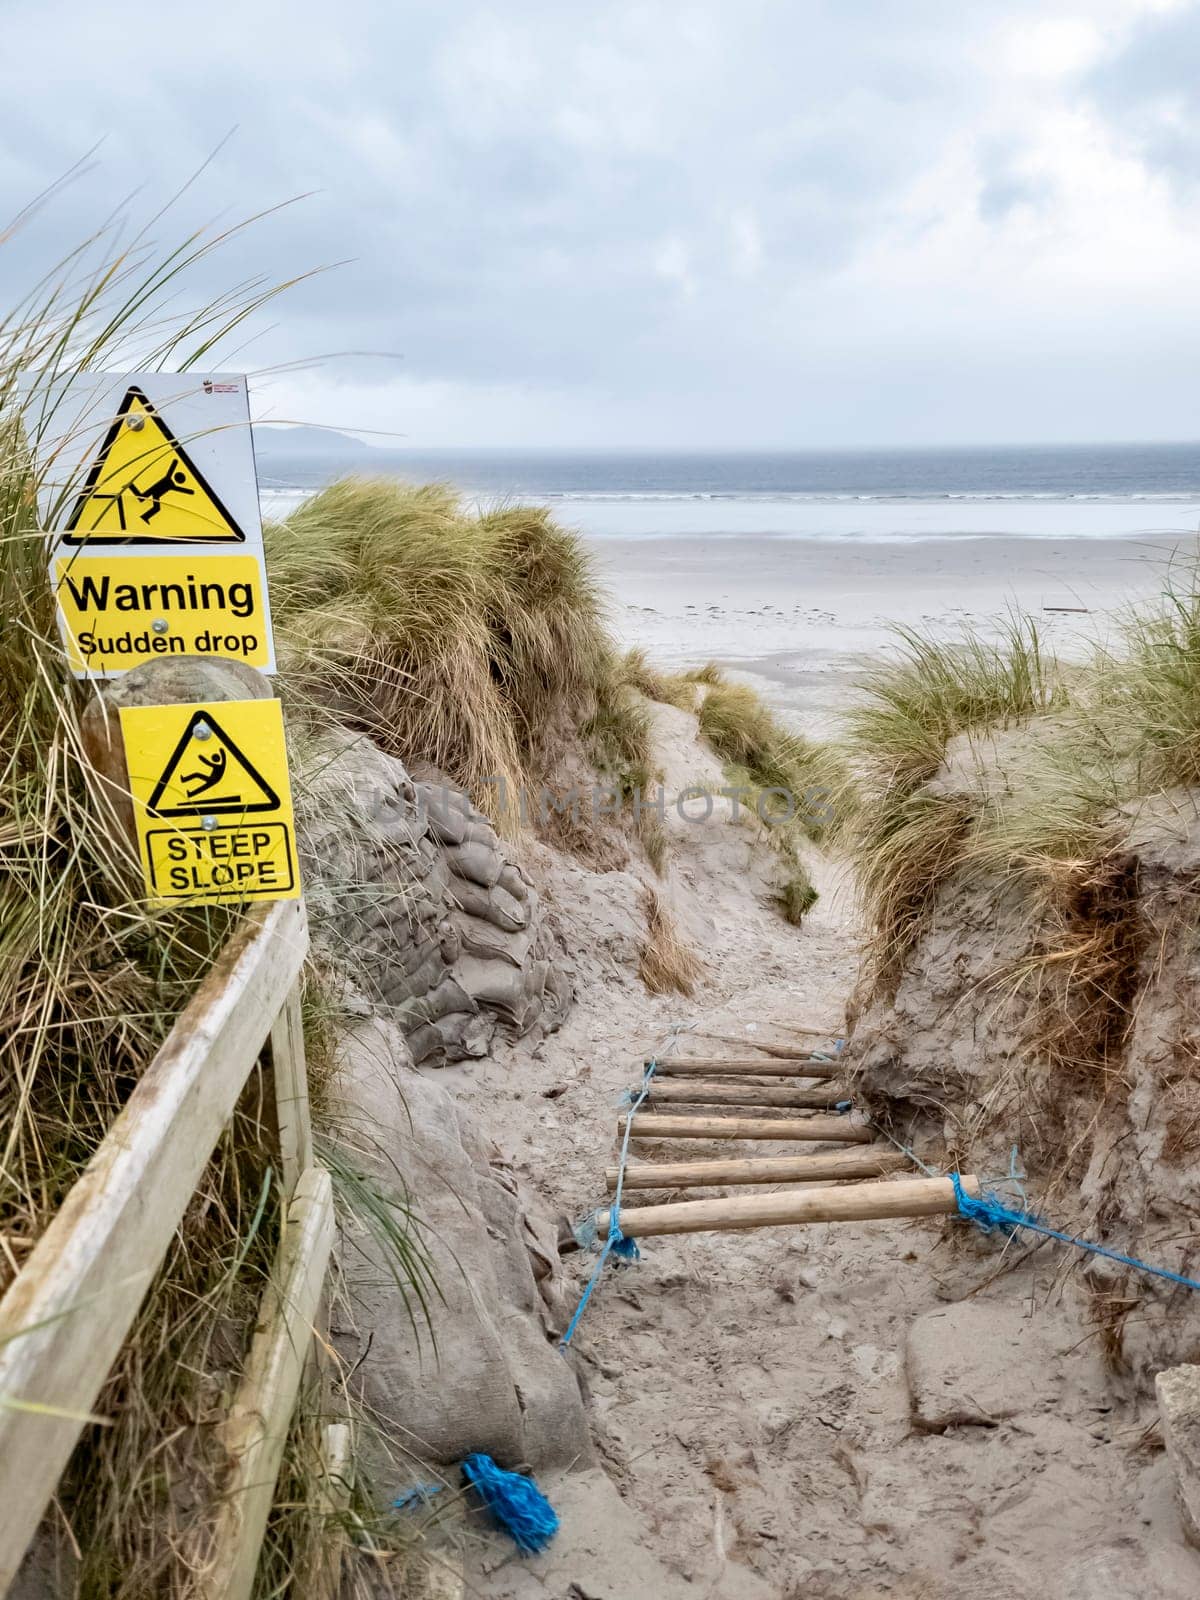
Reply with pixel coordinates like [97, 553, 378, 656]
[598, 1178, 979, 1238]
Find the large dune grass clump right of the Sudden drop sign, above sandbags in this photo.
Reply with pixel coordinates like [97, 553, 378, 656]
[267, 478, 616, 838]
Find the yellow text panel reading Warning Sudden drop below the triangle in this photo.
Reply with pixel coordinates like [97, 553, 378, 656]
[53, 550, 270, 678]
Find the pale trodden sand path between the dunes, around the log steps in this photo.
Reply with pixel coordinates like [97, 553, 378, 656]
[453, 712, 1200, 1600]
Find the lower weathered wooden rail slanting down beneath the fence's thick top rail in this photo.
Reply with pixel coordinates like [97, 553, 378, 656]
[197, 1166, 333, 1600]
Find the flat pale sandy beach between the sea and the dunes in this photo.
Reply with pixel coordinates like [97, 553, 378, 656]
[589, 533, 1194, 731]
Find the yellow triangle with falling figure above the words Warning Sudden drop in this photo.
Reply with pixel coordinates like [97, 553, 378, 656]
[62, 387, 246, 544]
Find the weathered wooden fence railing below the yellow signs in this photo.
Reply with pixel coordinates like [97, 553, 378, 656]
[0, 901, 333, 1600]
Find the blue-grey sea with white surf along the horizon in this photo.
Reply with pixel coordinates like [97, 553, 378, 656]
[258, 434, 1200, 542]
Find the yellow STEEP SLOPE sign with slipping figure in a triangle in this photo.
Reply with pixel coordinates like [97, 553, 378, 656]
[120, 699, 301, 904]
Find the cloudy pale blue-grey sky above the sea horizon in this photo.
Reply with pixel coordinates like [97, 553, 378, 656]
[0, 0, 1200, 450]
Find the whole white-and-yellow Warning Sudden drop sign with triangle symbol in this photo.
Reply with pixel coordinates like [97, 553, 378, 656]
[26, 373, 275, 678]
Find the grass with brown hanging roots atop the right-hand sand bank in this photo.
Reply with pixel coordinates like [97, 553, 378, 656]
[851, 568, 1200, 1091]
